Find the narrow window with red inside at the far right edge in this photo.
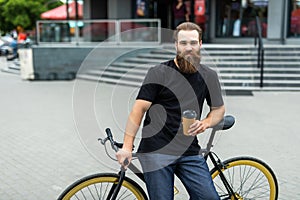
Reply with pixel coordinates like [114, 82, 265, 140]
[290, 0, 300, 37]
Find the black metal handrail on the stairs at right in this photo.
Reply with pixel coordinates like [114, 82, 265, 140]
[254, 16, 265, 88]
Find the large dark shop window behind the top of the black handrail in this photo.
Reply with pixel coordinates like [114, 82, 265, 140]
[216, 0, 268, 37]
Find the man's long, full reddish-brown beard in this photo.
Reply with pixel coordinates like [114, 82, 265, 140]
[176, 52, 201, 74]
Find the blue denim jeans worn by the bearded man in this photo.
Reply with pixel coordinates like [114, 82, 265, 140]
[139, 154, 220, 200]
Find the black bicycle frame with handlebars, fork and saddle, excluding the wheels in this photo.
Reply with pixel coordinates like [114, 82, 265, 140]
[100, 116, 238, 200]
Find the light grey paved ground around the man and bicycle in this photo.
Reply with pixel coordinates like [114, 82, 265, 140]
[0, 64, 300, 200]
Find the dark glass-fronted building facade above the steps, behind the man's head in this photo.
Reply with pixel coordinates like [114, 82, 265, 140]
[84, 0, 300, 44]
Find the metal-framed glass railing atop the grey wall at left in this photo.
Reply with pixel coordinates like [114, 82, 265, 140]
[36, 19, 161, 45]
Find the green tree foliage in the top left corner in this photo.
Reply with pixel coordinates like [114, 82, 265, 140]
[0, 0, 62, 32]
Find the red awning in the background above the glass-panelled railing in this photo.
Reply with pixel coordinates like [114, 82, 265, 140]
[41, 1, 83, 20]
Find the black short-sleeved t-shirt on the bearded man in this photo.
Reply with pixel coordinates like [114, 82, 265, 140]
[137, 60, 223, 156]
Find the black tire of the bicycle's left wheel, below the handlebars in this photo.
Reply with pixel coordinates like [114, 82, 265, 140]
[58, 173, 148, 200]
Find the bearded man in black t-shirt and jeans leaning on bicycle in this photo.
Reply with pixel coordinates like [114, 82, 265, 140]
[116, 22, 225, 200]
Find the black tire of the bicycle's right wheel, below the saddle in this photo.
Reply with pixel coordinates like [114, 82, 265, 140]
[210, 156, 279, 200]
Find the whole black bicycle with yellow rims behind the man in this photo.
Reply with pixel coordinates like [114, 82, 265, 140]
[58, 115, 278, 200]
